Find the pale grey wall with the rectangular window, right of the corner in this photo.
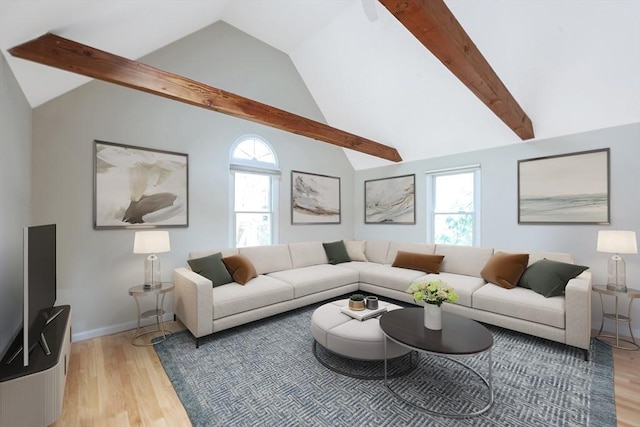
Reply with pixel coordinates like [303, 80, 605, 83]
[354, 123, 640, 336]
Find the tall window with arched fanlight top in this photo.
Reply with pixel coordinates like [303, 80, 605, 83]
[229, 136, 280, 247]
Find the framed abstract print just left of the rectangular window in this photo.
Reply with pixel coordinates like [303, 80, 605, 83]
[364, 174, 416, 224]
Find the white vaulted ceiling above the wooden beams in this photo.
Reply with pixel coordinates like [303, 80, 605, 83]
[0, 0, 640, 169]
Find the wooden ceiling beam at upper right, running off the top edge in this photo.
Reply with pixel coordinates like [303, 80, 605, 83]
[379, 0, 534, 140]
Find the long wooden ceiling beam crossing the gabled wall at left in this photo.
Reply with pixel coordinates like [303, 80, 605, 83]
[9, 33, 402, 162]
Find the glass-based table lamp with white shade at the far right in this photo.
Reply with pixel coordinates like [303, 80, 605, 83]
[597, 230, 638, 292]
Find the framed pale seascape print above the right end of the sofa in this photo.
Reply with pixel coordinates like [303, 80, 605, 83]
[518, 148, 610, 224]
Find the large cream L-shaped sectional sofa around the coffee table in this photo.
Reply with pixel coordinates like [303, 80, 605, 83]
[173, 240, 591, 359]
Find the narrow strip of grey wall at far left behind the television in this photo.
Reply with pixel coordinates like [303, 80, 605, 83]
[0, 54, 31, 357]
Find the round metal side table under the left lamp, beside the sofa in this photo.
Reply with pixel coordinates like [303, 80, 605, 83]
[129, 282, 174, 347]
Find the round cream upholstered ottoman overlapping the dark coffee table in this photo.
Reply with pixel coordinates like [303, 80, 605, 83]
[311, 299, 411, 360]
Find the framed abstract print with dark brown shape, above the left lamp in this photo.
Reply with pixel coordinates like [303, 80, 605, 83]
[93, 140, 189, 229]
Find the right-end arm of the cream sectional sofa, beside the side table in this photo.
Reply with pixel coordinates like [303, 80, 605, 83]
[564, 271, 591, 350]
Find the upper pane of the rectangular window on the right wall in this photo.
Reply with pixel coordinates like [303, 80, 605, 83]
[435, 172, 473, 212]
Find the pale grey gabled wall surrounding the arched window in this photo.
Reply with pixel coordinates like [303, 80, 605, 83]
[32, 22, 353, 339]
